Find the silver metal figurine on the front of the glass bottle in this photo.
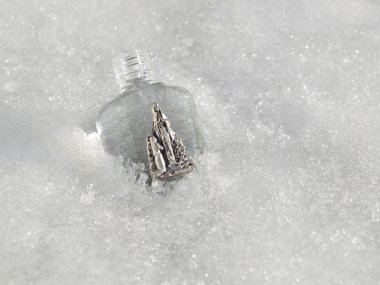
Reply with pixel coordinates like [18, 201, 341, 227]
[146, 103, 194, 184]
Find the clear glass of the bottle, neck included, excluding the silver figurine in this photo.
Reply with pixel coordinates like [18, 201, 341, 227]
[96, 50, 205, 169]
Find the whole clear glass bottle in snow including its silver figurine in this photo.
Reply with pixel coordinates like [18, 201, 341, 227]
[96, 51, 205, 179]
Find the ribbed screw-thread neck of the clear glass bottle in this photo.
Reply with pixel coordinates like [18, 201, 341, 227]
[115, 50, 152, 91]
